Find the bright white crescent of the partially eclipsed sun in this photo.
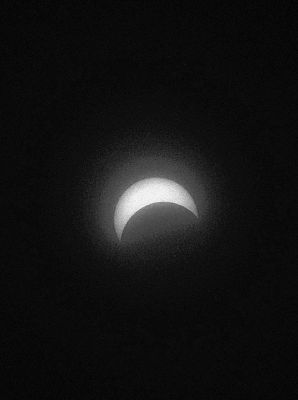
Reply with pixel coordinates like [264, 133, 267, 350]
[114, 178, 198, 240]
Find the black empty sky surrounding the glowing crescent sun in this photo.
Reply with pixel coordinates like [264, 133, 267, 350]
[1, 1, 297, 399]
